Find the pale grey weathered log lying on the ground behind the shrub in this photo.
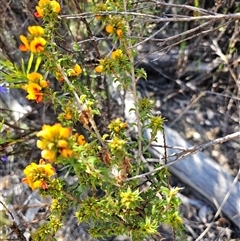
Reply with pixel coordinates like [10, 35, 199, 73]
[146, 127, 240, 228]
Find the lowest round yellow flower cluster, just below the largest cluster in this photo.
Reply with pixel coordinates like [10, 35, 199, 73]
[22, 159, 55, 191]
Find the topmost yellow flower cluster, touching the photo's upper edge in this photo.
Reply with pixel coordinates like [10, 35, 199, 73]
[34, 0, 61, 18]
